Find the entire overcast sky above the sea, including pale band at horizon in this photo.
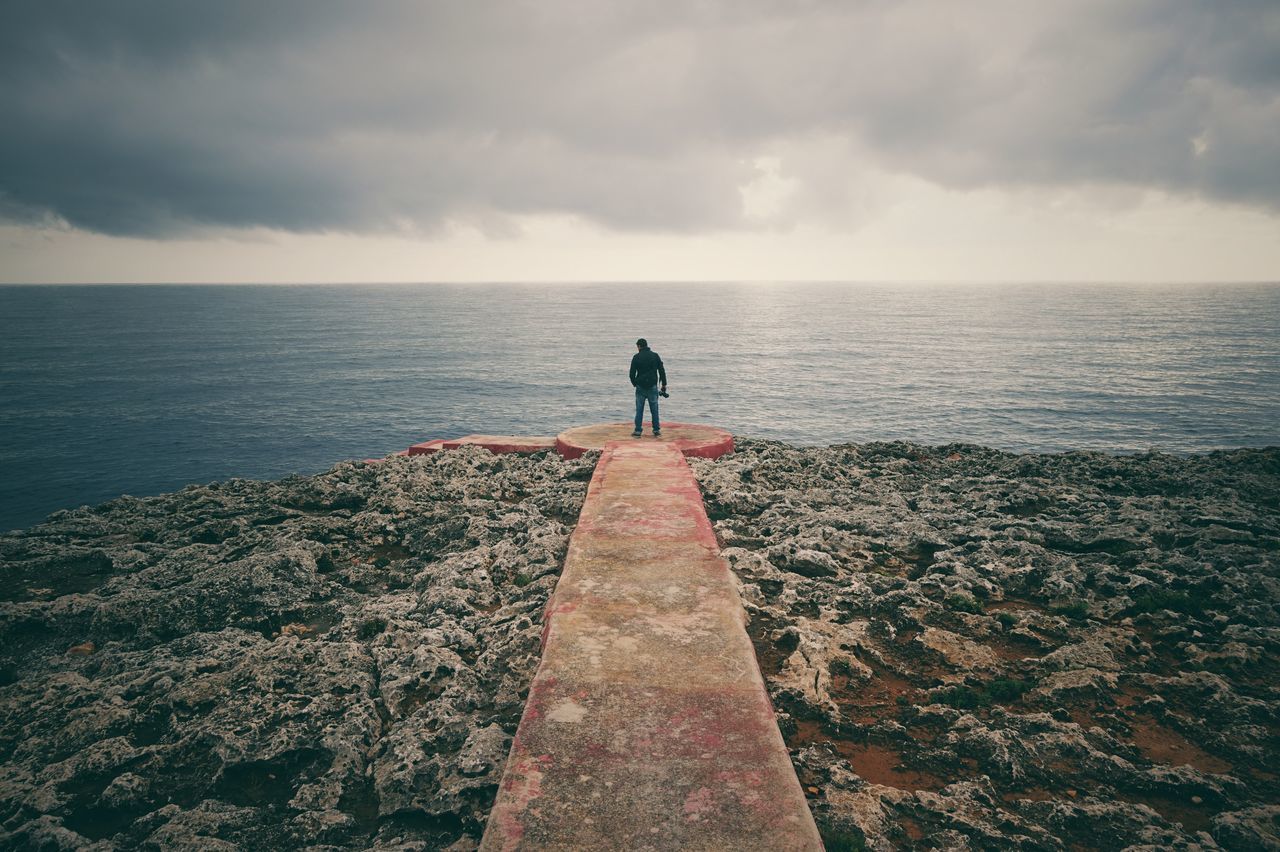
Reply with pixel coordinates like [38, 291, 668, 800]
[0, 0, 1280, 281]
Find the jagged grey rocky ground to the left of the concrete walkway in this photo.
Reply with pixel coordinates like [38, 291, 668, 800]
[0, 449, 595, 849]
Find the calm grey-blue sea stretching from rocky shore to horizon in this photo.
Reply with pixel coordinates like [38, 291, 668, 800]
[0, 284, 1280, 528]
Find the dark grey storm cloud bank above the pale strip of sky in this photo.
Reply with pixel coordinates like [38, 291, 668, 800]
[0, 0, 1280, 235]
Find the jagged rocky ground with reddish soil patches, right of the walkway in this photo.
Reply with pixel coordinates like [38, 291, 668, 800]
[692, 441, 1280, 849]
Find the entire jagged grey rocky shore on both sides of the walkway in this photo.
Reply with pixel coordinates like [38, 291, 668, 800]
[0, 440, 1280, 849]
